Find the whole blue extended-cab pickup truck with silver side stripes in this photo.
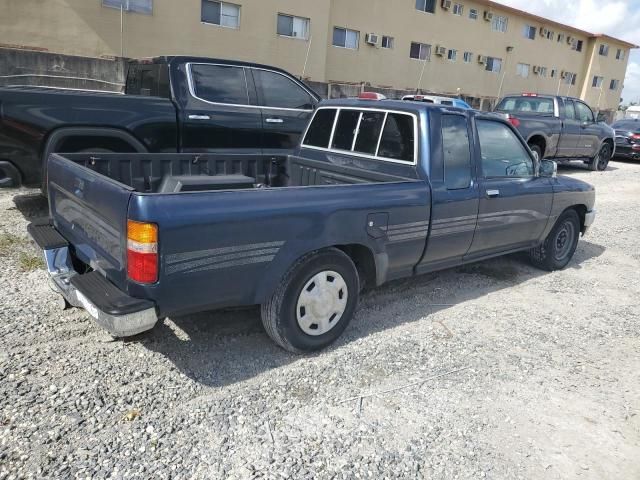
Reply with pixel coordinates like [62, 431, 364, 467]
[29, 99, 595, 352]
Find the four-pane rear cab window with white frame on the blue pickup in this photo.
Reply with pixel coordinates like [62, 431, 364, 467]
[302, 107, 418, 165]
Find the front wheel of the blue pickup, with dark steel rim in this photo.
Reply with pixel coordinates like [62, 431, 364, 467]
[529, 210, 580, 272]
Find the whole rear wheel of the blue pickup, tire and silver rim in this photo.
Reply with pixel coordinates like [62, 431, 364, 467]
[261, 248, 360, 353]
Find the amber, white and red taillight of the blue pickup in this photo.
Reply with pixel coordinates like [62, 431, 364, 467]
[127, 220, 158, 283]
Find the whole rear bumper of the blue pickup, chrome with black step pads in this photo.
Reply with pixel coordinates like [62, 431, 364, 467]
[28, 223, 158, 337]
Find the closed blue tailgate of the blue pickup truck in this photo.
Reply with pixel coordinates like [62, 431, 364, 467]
[48, 154, 134, 291]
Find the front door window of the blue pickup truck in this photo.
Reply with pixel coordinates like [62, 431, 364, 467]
[476, 120, 534, 178]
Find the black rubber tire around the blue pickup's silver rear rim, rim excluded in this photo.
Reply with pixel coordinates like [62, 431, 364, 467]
[261, 248, 360, 353]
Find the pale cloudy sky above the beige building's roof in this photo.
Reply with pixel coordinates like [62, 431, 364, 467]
[496, 0, 640, 103]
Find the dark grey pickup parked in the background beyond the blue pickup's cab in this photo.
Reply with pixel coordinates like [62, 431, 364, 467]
[495, 93, 616, 170]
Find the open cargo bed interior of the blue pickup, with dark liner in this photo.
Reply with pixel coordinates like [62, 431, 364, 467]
[53, 153, 411, 193]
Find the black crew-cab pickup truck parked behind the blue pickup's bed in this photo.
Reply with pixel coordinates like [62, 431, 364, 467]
[0, 56, 320, 190]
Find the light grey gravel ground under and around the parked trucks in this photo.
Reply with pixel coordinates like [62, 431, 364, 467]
[0, 162, 640, 480]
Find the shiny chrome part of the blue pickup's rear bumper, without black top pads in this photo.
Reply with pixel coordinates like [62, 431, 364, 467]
[43, 247, 158, 337]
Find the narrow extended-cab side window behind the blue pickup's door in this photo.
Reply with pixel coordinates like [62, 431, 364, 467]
[442, 115, 471, 190]
